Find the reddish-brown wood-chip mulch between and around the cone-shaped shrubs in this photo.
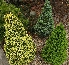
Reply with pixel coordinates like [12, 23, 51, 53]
[30, 0, 69, 65]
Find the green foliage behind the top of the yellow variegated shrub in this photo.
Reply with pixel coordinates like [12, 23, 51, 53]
[0, 0, 28, 40]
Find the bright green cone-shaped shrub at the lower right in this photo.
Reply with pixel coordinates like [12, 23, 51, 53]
[41, 24, 67, 65]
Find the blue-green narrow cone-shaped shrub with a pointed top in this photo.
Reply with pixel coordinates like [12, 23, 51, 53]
[34, 0, 54, 37]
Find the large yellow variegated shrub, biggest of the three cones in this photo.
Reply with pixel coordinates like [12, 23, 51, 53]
[4, 13, 36, 65]
